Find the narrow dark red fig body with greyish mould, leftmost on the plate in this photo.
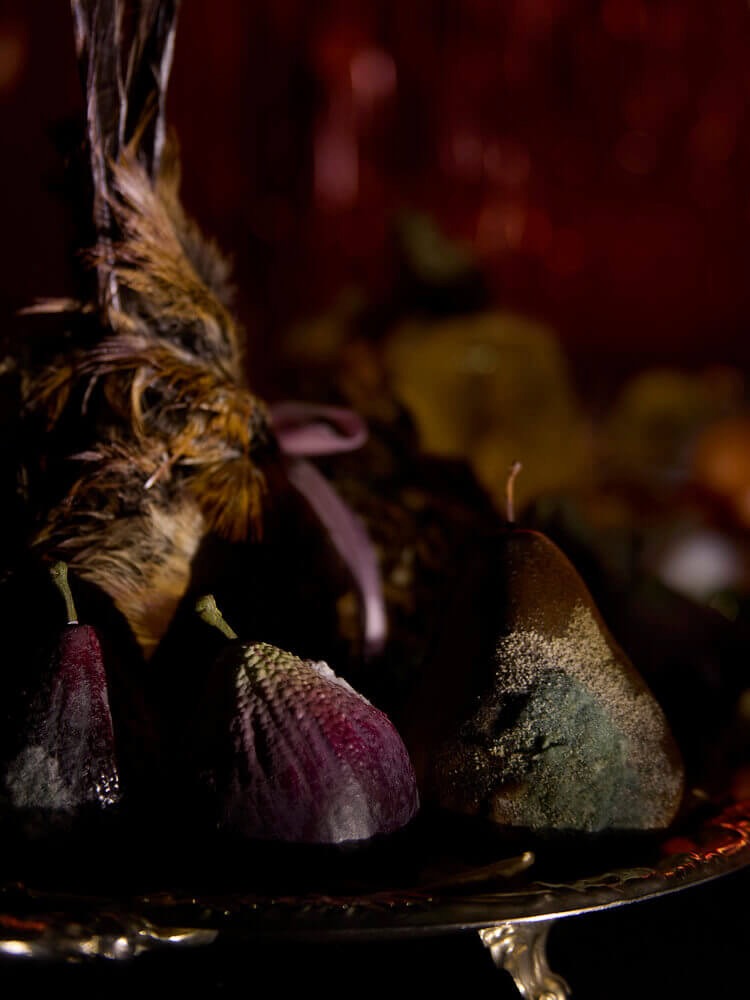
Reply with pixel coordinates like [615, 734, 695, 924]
[5, 624, 120, 813]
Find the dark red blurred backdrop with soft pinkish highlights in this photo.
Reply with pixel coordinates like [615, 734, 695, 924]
[0, 0, 750, 390]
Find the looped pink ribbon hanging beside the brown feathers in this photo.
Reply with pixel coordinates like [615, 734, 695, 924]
[270, 401, 388, 656]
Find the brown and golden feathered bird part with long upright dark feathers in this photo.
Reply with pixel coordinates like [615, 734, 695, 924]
[19, 0, 274, 656]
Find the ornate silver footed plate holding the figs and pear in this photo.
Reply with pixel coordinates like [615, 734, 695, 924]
[0, 800, 750, 1000]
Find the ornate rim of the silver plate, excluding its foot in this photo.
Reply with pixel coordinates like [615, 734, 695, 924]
[0, 800, 750, 958]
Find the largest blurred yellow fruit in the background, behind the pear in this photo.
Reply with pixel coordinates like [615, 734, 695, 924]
[385, 311, 591, 507]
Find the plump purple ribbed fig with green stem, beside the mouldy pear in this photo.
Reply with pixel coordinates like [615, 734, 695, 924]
[198, 598, 419, 844]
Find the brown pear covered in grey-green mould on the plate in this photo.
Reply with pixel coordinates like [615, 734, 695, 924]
[414, 468, 684, 833]
